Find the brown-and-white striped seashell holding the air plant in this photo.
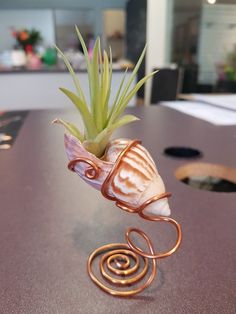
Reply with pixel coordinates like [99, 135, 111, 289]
[65, 134, 170, 216]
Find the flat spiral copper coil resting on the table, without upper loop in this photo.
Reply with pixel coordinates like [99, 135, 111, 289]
[87, 243, 156, 297]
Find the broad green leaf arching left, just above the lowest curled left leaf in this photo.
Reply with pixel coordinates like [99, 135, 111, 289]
[60, 88, 98, 138]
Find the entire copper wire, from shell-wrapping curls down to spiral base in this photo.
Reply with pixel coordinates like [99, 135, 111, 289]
[68, 140, 182, 297]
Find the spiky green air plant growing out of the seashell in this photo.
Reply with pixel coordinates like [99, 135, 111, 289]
[54, 27, 157, 157]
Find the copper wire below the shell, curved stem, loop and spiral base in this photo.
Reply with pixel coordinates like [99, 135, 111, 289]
[87, 201, 182, 297]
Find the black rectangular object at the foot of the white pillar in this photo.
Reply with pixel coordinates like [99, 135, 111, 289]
[151, 68, 182, 104]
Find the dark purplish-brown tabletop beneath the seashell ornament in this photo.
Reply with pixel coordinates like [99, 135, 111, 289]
[0, 106, 236, 314]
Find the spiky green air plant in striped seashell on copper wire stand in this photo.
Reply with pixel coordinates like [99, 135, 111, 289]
[53, 27, 181, 296]
